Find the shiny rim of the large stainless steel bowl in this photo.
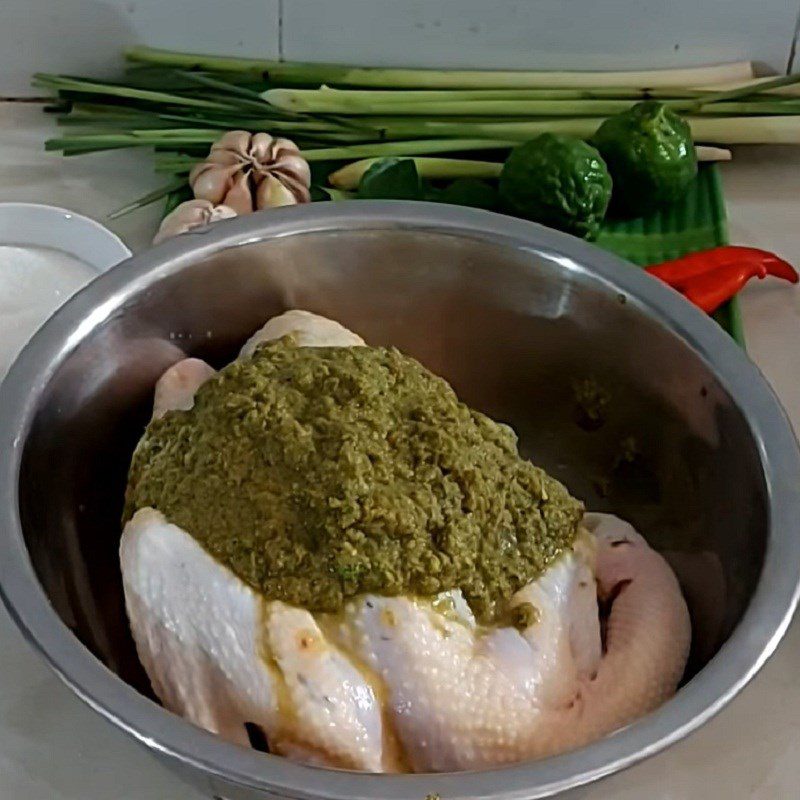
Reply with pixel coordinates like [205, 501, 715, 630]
[0, 201, 800, 800]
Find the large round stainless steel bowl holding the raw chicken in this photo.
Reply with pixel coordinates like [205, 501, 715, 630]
[0, 202, 800, 800]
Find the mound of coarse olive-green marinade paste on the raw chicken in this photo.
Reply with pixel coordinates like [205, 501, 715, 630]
[125, 337, 583, 622]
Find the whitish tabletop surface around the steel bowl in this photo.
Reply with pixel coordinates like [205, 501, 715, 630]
[0, 104, 800, 800]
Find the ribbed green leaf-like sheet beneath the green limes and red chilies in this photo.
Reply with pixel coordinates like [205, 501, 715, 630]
[596, 164, 744, 347]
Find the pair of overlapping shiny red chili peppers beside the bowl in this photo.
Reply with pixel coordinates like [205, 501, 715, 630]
[647, 245, 800, 314]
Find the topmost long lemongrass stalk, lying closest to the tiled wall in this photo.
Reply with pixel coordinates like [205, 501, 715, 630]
[125, 47, 753, 89]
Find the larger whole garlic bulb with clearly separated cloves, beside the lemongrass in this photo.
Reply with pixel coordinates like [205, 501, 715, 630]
[189, 131, 311, 214]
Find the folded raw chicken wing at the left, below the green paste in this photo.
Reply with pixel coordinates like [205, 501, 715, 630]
[120, 508, 383, 772]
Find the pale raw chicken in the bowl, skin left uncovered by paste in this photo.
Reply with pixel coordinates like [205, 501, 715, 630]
[120, 311, 690, 772]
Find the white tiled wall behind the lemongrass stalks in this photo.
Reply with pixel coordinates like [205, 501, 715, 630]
[0, 0, 800, 97]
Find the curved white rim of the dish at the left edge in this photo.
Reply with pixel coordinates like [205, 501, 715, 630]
[0, 203, 131, 273]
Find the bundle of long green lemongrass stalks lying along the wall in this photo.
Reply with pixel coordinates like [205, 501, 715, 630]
[34, 47, 800, 213]
